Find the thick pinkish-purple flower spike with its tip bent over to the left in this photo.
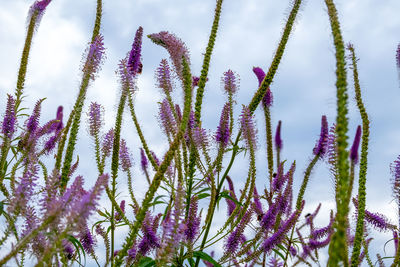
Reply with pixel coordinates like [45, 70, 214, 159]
[148, 31, 190, 78]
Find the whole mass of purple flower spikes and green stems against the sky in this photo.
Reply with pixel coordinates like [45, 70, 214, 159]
[0, 0, 400, 267]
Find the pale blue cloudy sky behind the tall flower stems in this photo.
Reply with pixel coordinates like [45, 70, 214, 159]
[0, 0, 400, 266]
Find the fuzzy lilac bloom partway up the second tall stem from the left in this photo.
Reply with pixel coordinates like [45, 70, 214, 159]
[82, 34, 105, 80]
